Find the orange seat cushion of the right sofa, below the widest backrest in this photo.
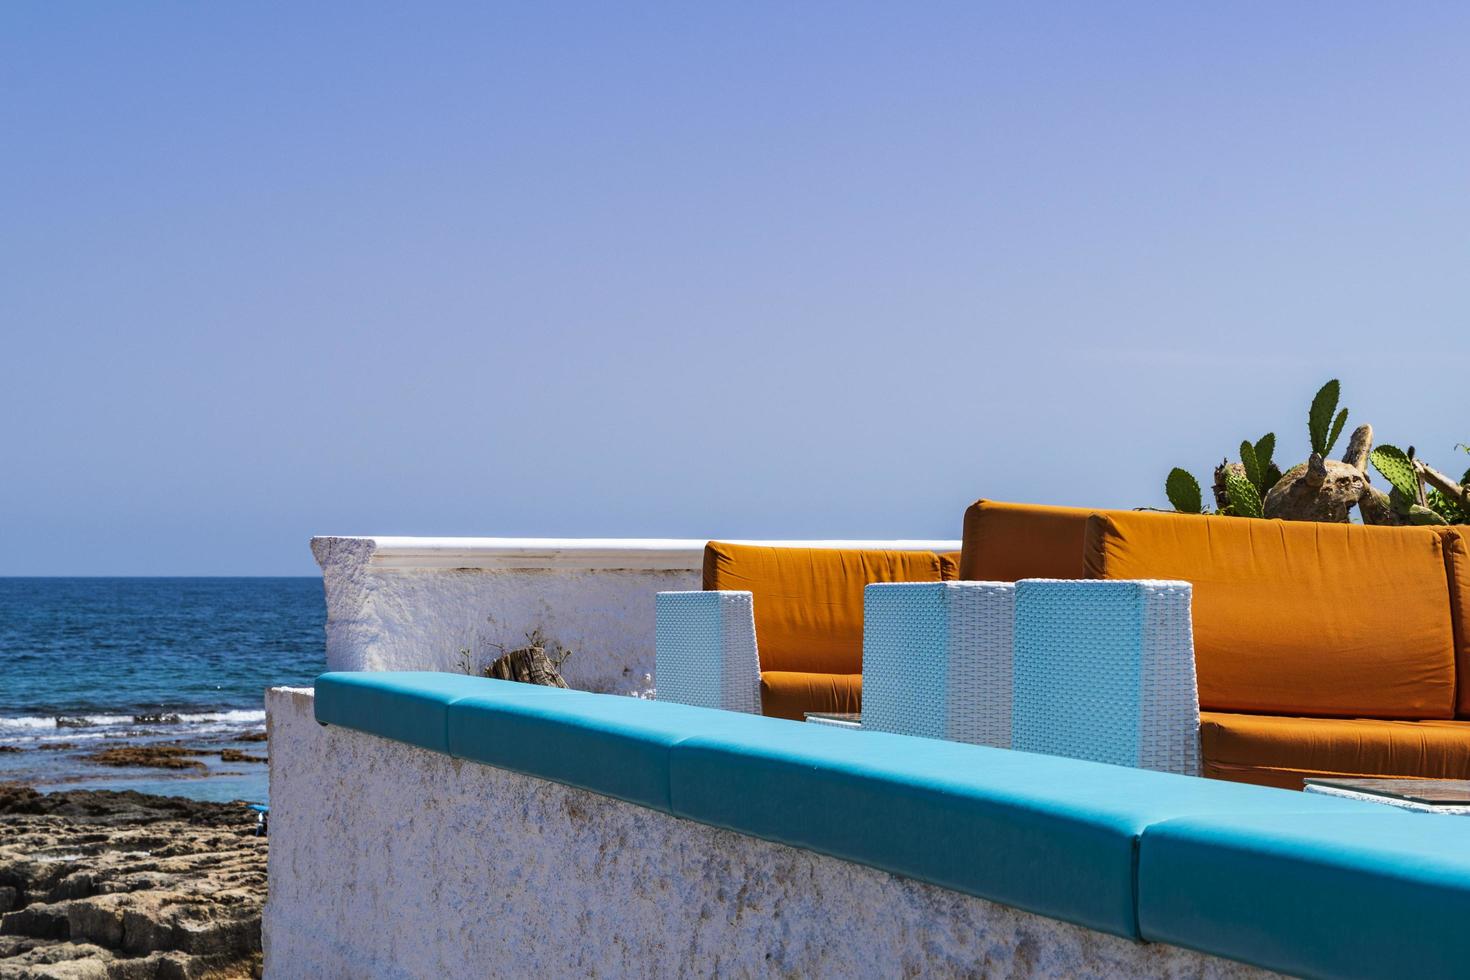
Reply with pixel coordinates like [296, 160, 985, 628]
[1200, 711, 1470, 789]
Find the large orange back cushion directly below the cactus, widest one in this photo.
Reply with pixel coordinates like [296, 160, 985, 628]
[1085, 511, 1455, 718]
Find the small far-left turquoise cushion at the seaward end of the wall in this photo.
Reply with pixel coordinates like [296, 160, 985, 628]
[316, 670, 551, 752]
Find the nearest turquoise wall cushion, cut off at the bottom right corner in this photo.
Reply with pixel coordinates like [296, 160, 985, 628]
[1138, 807, 1470, 977]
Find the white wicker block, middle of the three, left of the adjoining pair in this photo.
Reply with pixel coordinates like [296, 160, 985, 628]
[863, 582, 1016, 748]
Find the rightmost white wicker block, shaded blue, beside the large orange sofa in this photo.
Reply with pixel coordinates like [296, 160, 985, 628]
[1011, 579, 1200, 776]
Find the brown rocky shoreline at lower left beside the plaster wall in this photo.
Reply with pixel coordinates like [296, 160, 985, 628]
[0, 785, 266, 980]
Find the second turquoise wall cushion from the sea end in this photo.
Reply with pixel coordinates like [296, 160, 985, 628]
[448, 688, 809, 813]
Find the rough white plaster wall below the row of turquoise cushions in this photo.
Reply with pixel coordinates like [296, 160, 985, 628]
[265, 689, 1270, 980]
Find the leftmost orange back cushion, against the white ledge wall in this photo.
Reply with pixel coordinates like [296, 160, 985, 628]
[704, 541, 941, 674]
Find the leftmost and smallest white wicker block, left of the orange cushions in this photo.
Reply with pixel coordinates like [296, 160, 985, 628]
[654, 592, 760, 714]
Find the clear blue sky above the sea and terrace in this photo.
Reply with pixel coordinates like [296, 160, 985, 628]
[0, 3, 1470, 574]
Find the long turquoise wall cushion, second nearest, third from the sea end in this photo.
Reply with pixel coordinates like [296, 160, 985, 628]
[670, 724, 1387, 937]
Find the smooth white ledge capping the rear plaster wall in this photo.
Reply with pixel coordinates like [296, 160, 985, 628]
[312, 535, 960, 572]
